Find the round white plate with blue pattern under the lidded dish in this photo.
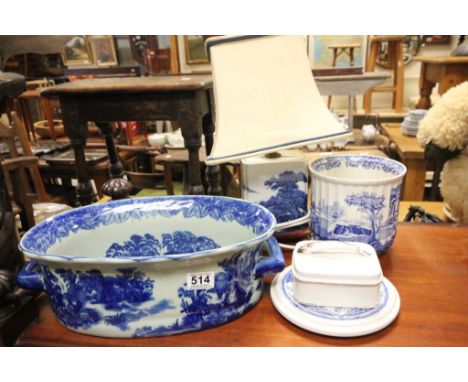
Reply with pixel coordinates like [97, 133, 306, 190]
[270, 266, 400, 337]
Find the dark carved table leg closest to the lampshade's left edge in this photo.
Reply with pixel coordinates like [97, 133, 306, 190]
[177, 100, 205, 195]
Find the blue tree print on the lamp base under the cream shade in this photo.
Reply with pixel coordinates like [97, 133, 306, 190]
[260, 171, 307, 223]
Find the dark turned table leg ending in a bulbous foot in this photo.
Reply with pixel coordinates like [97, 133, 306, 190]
[96, 122, 133, 200]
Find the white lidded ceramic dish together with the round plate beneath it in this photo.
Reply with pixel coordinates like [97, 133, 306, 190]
[270, 240, 400, 337]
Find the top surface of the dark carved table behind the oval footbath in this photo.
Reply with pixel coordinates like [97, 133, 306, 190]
[41, 75, 213, 97]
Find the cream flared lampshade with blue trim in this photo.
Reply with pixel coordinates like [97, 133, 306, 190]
[206, 36, 351, 165]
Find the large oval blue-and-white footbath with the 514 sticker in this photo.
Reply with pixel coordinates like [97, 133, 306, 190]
[18, 196, 284, 337]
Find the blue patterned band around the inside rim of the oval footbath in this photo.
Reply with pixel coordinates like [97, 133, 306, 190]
[20, 196, 272, 255]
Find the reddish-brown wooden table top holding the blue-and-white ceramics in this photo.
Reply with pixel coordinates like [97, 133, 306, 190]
[17, 223, 468, 346]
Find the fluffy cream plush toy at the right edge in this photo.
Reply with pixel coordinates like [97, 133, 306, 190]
[417, 81, 468, 223]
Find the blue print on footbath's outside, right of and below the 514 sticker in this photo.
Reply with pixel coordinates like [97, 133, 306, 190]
[134, 247, 263, 337]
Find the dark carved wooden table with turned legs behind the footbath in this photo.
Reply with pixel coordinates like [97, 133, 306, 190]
[41, 75, 221, 205]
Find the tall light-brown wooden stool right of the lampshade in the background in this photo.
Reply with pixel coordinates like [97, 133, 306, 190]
[363, 36, 405, 113]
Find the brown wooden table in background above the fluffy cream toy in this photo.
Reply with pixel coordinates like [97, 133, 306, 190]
[414, 56, 468, 109]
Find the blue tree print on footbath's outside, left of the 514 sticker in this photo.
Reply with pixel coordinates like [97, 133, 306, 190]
[43, 266, 174, 330]
